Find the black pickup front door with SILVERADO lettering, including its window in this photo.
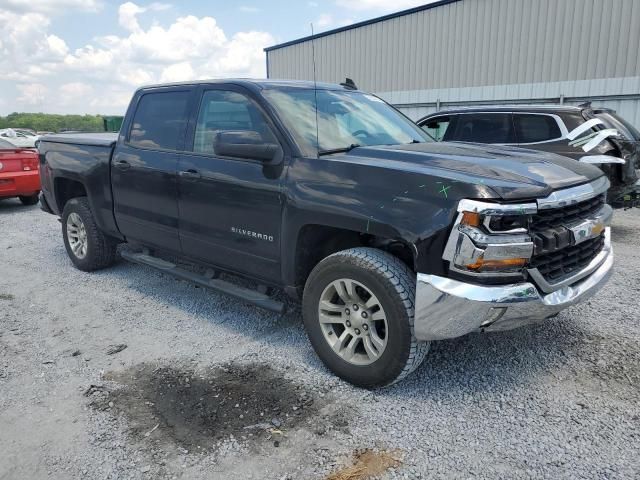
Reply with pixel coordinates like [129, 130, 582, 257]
[178, 85, 284, 281]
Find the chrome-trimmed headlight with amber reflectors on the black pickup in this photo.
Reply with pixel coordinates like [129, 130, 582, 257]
[443, 200, 537, 276]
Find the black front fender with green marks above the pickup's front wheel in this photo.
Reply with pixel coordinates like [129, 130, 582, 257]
[282, 157, 495, 285]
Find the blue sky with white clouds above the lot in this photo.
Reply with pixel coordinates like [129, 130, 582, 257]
[0, 0, 429, 115]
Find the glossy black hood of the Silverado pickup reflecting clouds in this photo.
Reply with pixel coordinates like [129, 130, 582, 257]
[344, 142, 603, 200]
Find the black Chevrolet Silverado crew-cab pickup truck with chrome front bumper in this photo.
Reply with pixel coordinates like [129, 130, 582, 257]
[39, 80, 613, 387]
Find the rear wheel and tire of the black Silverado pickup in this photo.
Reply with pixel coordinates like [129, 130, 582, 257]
[62, 197, 117, 272]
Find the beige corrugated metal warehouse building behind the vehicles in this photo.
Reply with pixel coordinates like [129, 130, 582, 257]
[265, 0, 640, 126]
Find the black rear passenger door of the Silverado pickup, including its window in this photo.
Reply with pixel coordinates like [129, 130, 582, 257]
[111, 87, 193, 252]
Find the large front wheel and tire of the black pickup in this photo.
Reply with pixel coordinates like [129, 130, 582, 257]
[302, 247, 429, 388]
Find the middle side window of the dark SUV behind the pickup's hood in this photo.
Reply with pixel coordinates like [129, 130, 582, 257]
[447, 112, 516, 143]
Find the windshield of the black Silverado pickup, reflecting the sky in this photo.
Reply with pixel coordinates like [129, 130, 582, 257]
[264, 88, 432, 156]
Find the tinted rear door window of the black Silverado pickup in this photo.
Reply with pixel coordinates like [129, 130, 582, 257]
[129, 90, 190, 150]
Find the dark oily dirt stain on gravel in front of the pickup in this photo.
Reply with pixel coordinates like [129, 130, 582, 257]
[86, 364, 321, 451]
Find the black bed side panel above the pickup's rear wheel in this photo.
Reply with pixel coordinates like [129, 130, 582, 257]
[39, 140, 121, 238]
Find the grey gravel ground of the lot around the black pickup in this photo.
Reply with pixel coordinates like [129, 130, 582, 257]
[0, 200, 640, 479]
